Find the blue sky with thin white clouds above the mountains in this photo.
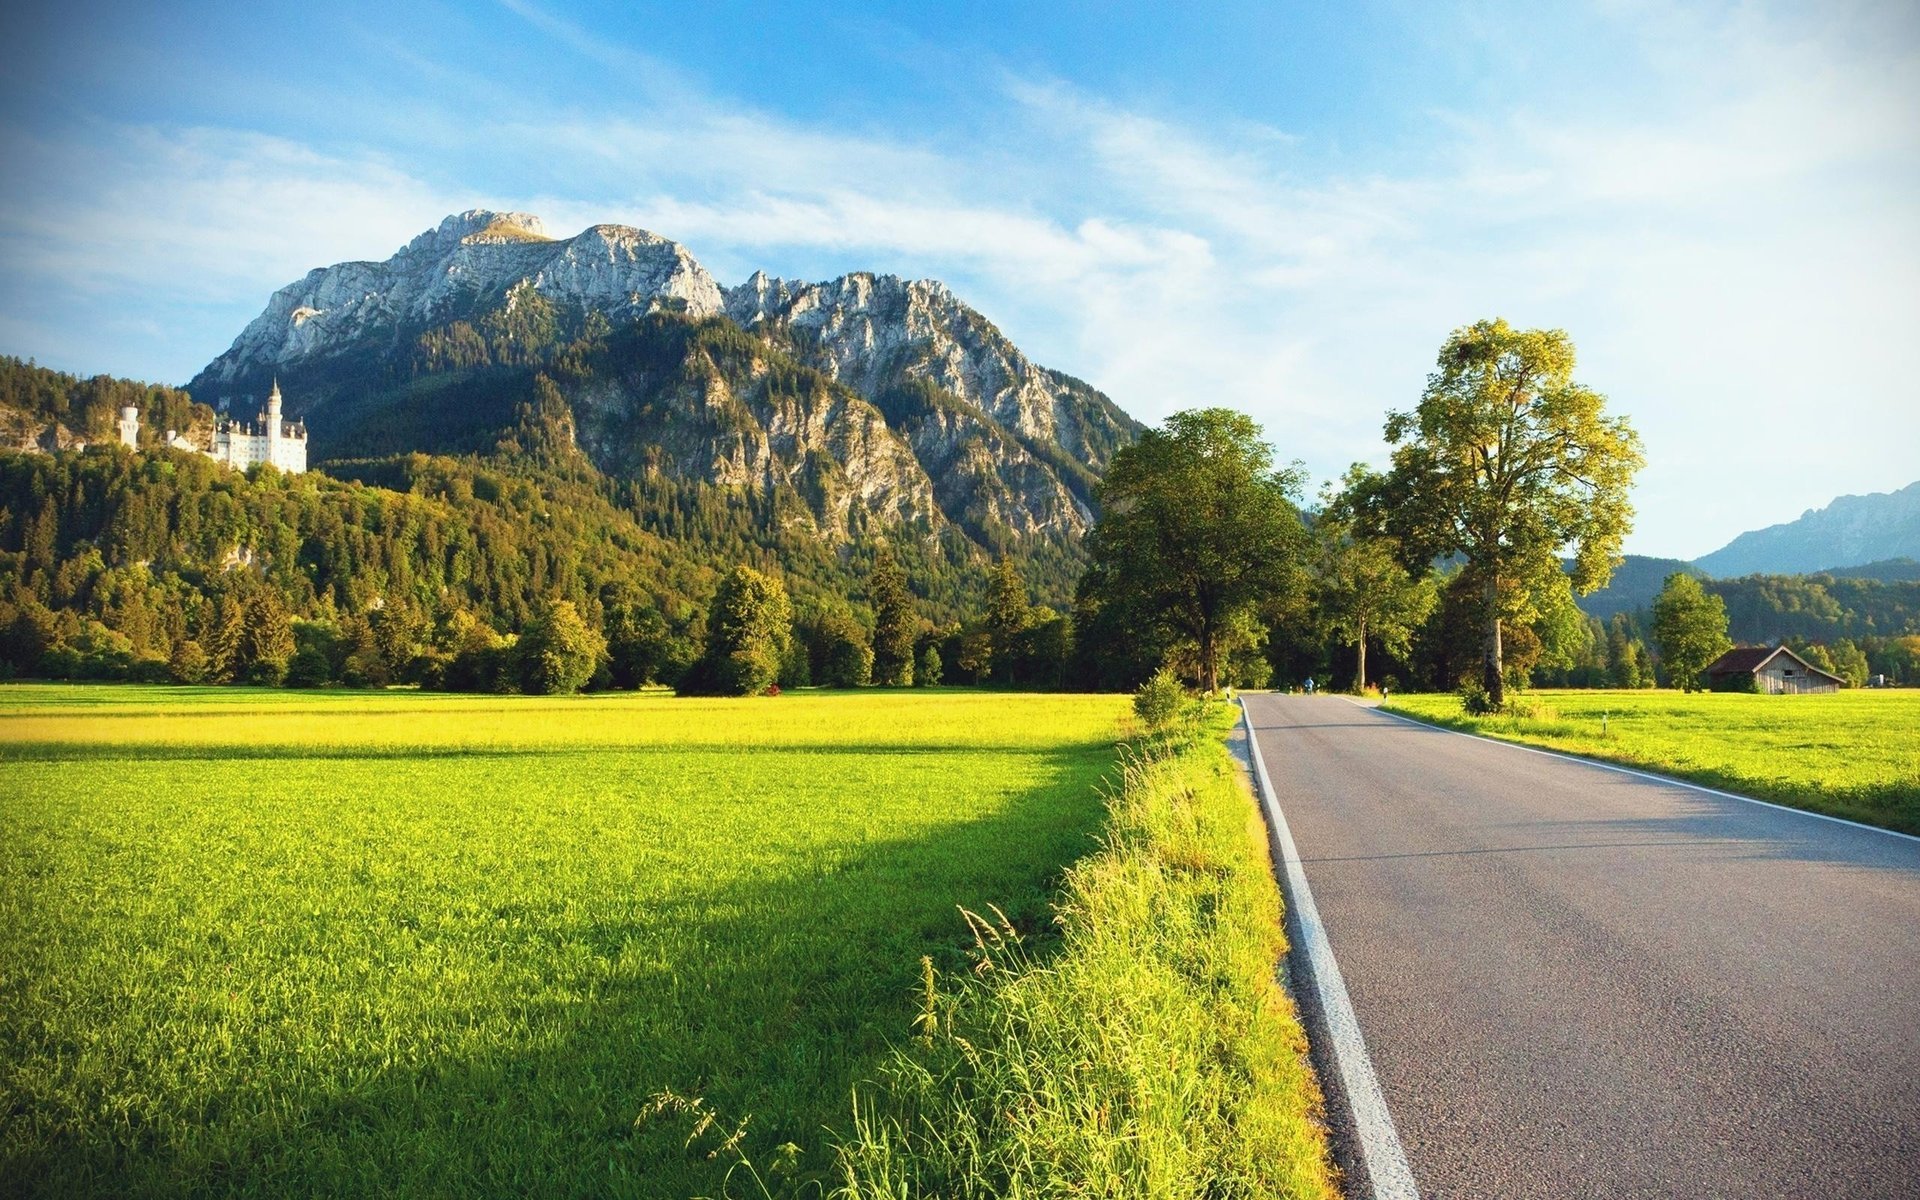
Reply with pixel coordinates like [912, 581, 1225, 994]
[0, 0, 1920, 557]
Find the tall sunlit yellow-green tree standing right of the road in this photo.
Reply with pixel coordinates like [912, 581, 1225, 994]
[1369, 321, 1644, 707]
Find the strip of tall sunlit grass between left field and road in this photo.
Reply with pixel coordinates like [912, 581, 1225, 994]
[833, 710, 1338, 1200]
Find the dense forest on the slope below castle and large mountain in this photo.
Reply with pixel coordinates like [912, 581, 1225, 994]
[0, 435, 1083, 691]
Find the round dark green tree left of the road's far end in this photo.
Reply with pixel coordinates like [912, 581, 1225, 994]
[1081, 409, 1308, 689]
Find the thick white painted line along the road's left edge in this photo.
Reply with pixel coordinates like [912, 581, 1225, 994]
[1240, 697, 1419, 1200]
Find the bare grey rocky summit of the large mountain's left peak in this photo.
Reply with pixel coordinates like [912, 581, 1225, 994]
[200, 209, 724, 385]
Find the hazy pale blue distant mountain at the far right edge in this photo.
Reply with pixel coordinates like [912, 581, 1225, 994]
[1693, 482, 1920, 578]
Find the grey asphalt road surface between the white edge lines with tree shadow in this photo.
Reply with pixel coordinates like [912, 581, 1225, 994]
[1248, 695, 1920, 1200]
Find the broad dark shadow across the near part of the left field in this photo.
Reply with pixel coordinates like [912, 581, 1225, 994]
[0, 747, 1112, 1196]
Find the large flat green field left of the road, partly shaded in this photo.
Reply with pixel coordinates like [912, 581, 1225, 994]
[0, 685, 1125, 1196]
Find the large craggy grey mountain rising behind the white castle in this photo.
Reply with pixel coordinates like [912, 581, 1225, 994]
[188, 211, 1140, 555]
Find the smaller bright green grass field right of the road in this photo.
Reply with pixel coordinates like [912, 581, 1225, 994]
[1388, 691, 1920, 833]
